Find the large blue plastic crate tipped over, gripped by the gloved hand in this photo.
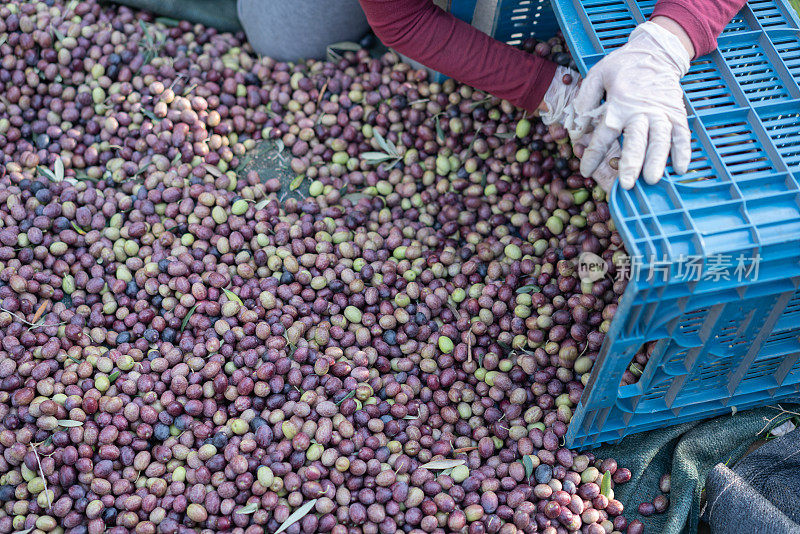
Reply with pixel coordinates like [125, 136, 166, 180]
[554, 0, 800, 447]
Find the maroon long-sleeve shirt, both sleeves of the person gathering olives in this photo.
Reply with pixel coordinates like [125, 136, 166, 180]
[359, 0, 745, 112]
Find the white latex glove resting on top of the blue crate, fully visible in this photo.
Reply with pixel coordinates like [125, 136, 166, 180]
[572, 22, 691, 189]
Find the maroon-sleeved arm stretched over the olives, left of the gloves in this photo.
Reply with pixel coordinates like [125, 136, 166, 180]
[359, 0, 556, 112]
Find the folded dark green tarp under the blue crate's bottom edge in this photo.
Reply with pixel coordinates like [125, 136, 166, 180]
[594, 404, 800, 534]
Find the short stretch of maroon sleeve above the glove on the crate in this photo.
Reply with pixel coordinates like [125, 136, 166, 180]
[650, 0, 747, 57]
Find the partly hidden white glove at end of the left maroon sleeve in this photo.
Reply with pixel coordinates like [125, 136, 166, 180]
[539, 66, 621, 191]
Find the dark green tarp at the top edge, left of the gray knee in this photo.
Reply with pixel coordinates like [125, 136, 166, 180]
[111, 0, 242, 32]
